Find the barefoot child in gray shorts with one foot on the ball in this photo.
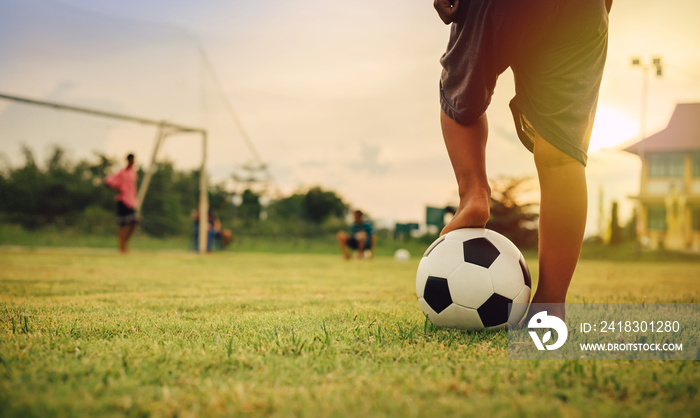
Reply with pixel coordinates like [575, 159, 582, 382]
[434, 0, 612, 318]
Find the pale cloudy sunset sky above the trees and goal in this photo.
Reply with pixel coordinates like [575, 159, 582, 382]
[0, 0, 700, 234]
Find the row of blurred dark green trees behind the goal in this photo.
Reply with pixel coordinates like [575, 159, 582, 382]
[0, 147, 348, 237]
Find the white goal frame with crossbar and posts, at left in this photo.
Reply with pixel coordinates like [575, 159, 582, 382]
[0, 93, 209, 253]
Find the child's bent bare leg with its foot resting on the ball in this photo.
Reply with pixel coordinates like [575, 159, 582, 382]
[440, 112, 491, 235]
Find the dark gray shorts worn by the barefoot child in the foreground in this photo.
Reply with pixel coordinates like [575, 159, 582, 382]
[440, 0, 609, 165]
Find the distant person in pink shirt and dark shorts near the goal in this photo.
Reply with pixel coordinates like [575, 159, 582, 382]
[104, 154, 138, 254]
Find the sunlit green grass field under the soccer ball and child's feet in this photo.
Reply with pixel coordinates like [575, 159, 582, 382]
[0, 247, 700, 417]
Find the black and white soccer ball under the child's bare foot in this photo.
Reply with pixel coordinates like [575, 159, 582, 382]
[416, 228, 531, 330]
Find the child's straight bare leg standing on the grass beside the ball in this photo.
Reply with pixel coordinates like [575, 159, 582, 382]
[529, 134, 588, 318]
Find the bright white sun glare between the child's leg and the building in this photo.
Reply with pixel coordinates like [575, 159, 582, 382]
[588, 105, 639, 152]
